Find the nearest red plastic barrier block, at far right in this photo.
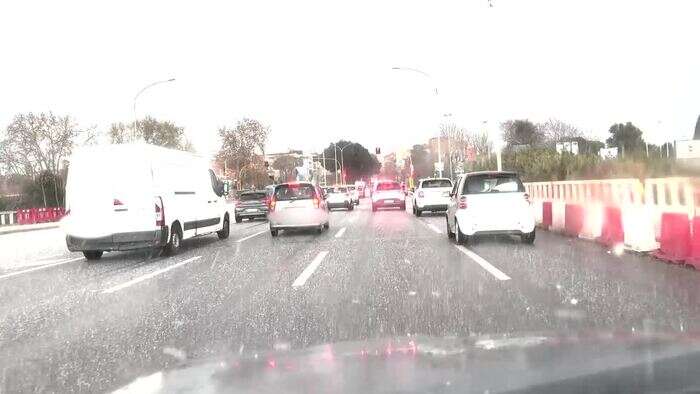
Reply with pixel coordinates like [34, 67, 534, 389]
[654, 213, 690, 264]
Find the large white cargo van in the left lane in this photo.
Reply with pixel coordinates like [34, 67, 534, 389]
[61, 143, 230, 260]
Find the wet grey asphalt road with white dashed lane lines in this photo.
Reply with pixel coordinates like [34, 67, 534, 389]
[0, 199, 700, 392]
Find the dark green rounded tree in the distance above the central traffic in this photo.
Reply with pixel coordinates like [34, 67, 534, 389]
[321, 140, 381, 182]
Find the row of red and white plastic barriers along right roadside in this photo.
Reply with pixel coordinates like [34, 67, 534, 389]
[526, 178, 700, 260]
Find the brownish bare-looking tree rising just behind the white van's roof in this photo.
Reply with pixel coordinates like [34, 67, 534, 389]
[108, 116, 194, 151]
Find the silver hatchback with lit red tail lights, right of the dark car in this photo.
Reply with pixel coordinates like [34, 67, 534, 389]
[267, 182, 330, 237]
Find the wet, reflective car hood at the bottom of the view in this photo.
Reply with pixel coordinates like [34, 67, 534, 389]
[117, 332, 700, 393]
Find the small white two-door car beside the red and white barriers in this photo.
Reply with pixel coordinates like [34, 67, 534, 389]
[446, 171, 535, 244]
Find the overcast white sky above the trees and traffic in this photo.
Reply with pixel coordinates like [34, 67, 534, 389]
[0, 0, 700, 157]
